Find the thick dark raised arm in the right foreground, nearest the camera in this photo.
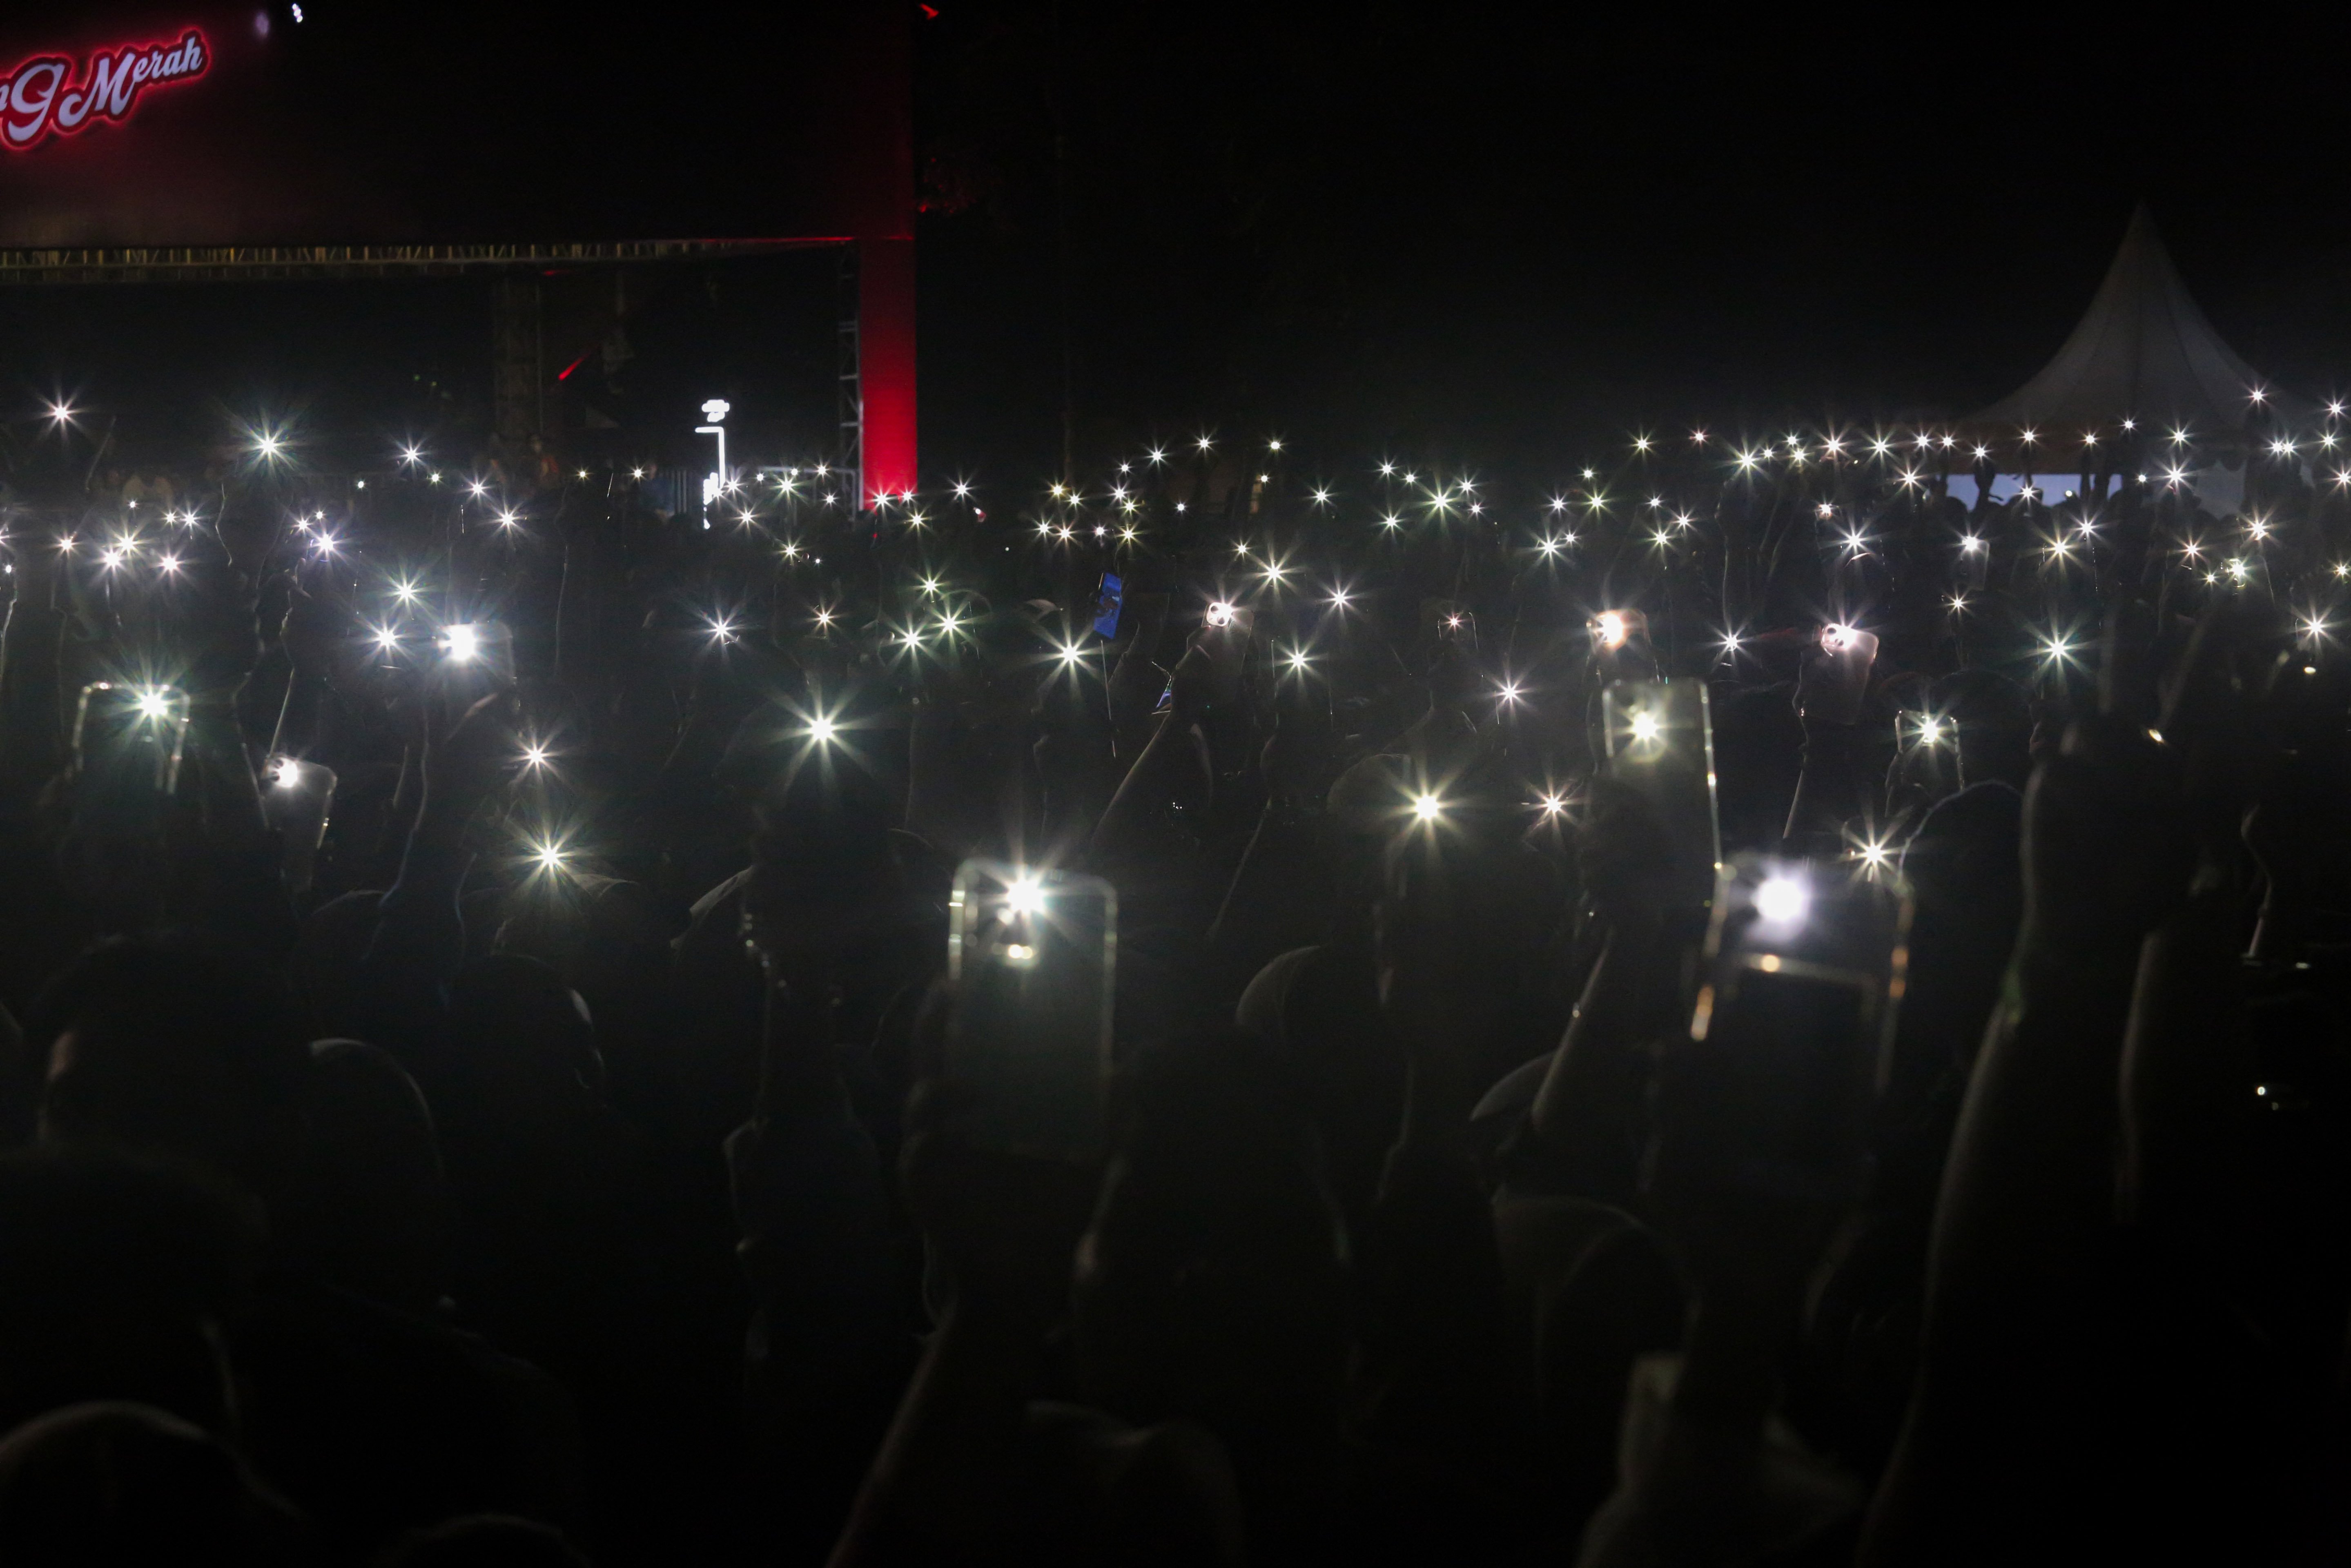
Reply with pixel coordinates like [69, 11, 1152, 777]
[1862, 719, 2186, 1568]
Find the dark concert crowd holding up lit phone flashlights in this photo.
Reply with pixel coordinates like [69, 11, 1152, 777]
[0, 414, 2351, 1568]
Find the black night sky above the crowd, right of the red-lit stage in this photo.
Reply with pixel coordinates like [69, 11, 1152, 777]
[924, 5, 2351, 472]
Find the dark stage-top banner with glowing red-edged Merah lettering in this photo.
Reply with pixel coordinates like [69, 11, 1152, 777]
[0, 0, 912, 249]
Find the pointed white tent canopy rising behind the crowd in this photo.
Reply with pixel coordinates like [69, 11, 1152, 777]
[1968, 202, 2306, 435]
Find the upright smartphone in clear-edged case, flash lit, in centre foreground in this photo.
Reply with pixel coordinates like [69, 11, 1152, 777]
[947, 860, 1119, 1161]
